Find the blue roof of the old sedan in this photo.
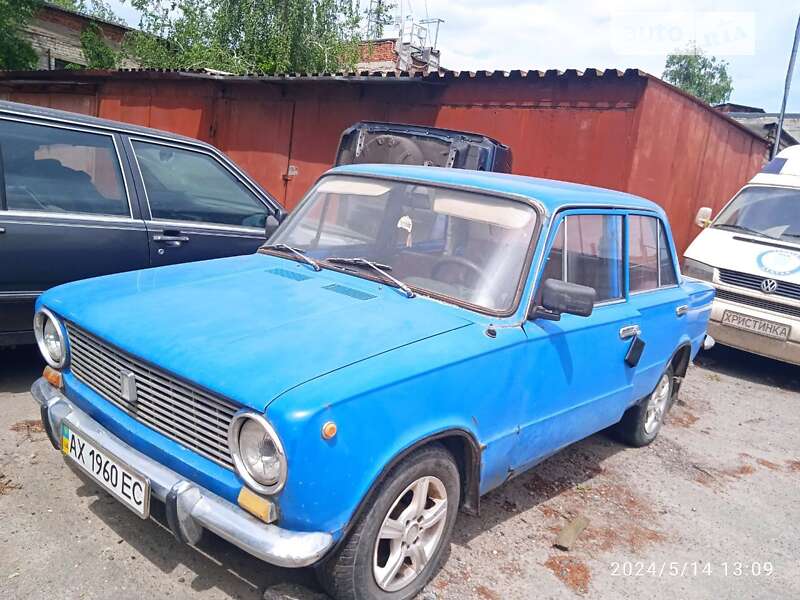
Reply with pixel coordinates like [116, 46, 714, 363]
[328, 164, 663, 214]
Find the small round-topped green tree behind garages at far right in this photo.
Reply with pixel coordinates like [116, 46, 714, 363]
[662, 43, 733, 104]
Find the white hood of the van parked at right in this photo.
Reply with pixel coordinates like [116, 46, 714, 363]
[684, 227, 800, 283]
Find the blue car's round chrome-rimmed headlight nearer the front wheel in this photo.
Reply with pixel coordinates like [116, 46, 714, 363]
[228, 412, 286, 494]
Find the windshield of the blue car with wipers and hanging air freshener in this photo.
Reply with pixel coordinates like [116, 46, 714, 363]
[270, 176, 536, 312]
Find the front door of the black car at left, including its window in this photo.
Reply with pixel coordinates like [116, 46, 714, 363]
[127, 137, 279, 266]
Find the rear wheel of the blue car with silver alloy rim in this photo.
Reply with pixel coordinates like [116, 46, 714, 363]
[614, 365, 675, 448]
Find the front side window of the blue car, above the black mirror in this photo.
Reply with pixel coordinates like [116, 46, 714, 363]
[543, 215, 623, 302]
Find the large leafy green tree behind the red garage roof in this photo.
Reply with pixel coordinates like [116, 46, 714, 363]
[125, 0, 359, 73]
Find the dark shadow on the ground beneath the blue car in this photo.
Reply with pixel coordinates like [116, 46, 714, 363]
[65, 426, 625, 600]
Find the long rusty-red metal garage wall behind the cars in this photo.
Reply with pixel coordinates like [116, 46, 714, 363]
[0, 72, 766, 251]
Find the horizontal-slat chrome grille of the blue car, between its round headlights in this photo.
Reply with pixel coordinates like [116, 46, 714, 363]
[67, 323, 237, 469]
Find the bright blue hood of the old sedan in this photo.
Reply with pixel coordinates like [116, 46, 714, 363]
[39, 254, 470, 410]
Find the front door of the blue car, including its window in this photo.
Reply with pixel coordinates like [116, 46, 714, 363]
[509, 211, 640, 471]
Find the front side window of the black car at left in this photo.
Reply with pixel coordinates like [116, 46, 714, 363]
[132, 141, 269, 227]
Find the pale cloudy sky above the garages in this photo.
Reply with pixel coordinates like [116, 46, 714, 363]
[110, 0, 800, 112]
